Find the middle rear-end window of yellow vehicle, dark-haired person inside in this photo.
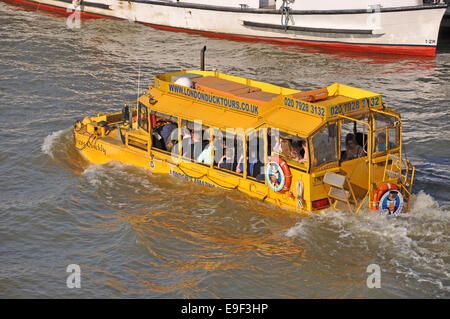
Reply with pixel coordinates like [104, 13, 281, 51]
[340, 118, 368, 161]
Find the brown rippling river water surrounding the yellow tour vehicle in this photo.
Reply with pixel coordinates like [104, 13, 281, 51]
[0, 2, 450, 298]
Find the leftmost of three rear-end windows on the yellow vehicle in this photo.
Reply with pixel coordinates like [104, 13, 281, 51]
[312, 123, 337, 167]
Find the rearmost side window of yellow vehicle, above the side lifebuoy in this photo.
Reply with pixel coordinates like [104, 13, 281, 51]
[268, 128, 309, 164]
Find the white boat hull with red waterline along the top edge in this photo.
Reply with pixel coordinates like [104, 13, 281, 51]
[2, 0, 447, 56]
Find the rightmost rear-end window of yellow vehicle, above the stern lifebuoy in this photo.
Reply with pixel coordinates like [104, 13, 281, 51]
[373, 113, 400, 153]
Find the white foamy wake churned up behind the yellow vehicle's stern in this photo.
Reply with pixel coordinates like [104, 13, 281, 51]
[284, 191, 450, 295]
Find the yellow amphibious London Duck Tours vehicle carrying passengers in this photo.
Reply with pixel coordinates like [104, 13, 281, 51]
[74, 58, 415, 215]
